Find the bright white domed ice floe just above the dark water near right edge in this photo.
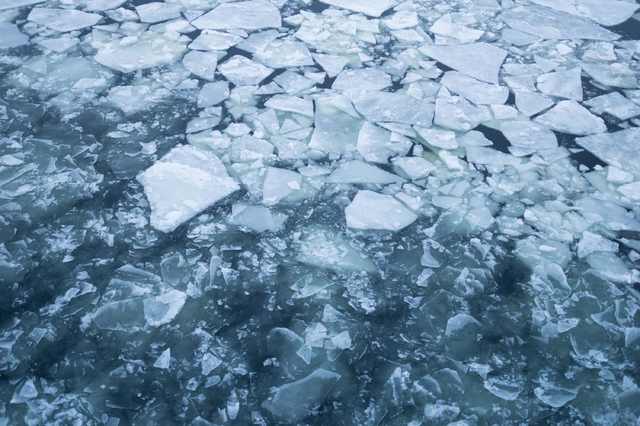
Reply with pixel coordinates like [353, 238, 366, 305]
[535, 101, 607, 136]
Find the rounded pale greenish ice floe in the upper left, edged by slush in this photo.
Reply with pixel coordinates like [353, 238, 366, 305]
[95, 31, 186, 73]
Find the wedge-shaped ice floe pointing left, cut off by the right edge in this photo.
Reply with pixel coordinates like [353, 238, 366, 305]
[576, 127, 640, 176]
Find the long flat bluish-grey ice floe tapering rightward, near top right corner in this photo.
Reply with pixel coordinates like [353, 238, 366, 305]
[502, 6, 620, 41]
